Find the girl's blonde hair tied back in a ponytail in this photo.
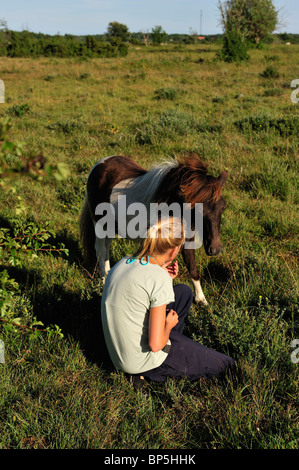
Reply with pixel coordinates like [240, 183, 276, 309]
[135, 217, 185, 259]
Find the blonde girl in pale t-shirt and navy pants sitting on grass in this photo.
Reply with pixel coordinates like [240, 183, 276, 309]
[101, 218, 235, 382]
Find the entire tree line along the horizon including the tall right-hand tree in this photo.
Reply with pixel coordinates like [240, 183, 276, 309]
[0, 4, 299, 62]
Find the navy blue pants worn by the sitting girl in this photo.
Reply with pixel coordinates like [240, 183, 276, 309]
[141, 284, 235, 382]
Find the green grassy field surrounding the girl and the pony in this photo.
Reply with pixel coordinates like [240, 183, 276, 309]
[0, 44, 299, 449]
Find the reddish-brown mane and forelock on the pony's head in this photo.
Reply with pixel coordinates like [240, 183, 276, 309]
[154, 154, 222, 207]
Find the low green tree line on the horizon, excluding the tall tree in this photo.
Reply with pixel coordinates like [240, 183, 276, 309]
[0, 20, 225, 58]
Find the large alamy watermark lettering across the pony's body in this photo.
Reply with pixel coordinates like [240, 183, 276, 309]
[95, 195, 203, 249]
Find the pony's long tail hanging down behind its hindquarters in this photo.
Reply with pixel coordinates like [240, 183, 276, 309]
[79, 195, 96, 268]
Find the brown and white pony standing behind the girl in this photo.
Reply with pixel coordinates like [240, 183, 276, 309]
[79, 155, 228, 305]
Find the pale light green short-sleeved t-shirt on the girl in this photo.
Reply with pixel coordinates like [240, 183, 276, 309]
[101, 257, 174, 374]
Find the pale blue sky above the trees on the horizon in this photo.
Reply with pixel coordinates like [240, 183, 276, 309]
[0, 0, 299, 35]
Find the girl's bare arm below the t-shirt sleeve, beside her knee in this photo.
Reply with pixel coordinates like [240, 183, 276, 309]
[149, 304, 178, 352]
